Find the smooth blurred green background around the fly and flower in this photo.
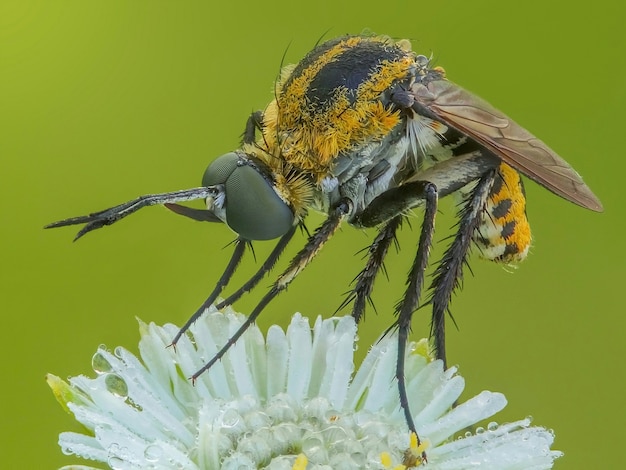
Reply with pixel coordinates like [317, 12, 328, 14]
[0, 0, 626, 469]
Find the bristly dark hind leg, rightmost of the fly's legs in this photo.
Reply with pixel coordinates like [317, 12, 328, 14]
[429, 170, 496, 367]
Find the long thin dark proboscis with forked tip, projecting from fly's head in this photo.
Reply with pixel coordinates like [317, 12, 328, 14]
[44, 187, 221, 241]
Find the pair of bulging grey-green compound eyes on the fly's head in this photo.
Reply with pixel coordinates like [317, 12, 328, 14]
[202, 153, 294, 240]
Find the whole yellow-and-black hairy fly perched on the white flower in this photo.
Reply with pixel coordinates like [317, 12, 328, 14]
[47, 36, 602, 458]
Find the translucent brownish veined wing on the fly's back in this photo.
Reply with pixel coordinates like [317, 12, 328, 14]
[412, 80, 603, 212]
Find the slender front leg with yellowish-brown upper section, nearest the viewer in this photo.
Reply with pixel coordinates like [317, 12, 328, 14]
[191, 200, 352, 381]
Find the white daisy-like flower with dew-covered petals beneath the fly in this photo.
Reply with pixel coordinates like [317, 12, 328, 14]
[48, 310, 561, 470]
